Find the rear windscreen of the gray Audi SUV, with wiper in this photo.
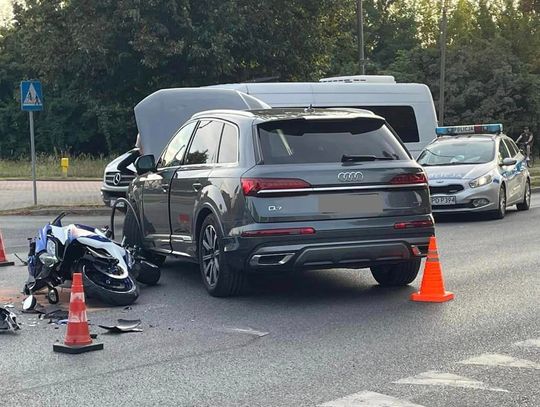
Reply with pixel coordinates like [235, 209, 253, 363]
[258, 119, 409, 164]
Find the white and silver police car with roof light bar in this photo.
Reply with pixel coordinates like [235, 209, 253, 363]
[418, 124, 531, 219]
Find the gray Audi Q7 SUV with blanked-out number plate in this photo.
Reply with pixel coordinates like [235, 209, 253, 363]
[124, 109, 434, 296]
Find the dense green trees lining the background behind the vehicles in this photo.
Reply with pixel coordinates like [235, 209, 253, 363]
[0, 0, 540, 158]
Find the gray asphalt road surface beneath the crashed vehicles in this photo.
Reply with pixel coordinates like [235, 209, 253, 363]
[0, 204, 540, 407]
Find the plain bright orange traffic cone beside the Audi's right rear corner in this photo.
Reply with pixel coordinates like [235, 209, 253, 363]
[411, 236, 454, 302]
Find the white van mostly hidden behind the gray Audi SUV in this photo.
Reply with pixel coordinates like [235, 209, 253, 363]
[207, 75, 437, 158]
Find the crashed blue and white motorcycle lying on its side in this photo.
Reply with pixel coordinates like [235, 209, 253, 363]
[24, 213, 161, 305]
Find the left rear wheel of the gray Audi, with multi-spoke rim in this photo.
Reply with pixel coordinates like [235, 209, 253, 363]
[197, 214, 246, 297]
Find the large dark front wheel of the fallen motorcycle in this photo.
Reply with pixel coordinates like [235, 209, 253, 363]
[79, 262, 139, 306]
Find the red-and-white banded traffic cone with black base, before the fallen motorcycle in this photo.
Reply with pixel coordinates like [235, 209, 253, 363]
[53, 273, 103, 353]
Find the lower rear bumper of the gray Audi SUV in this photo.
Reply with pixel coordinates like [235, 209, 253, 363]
[224, 217, 434, 273]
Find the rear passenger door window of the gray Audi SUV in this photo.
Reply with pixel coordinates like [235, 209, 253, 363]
[185, 120, 223, 165]
